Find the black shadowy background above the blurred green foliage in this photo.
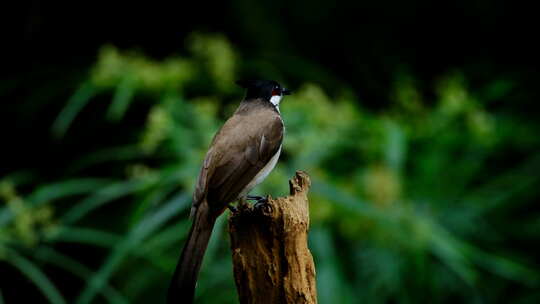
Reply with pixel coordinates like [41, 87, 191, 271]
[5, 0, 540, 176]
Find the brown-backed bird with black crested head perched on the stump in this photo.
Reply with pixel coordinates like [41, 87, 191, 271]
[167, 80, 291, 303]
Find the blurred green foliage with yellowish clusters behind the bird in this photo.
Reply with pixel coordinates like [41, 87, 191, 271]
[0, 34, 540, 303]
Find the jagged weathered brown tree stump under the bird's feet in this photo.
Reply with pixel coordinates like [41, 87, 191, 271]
[229, 171, 317, 304]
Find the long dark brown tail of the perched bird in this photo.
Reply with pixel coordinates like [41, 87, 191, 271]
[167, 203, 216, 304]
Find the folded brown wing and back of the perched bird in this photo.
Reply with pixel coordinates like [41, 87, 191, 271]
[193, 107, 283, 215]
